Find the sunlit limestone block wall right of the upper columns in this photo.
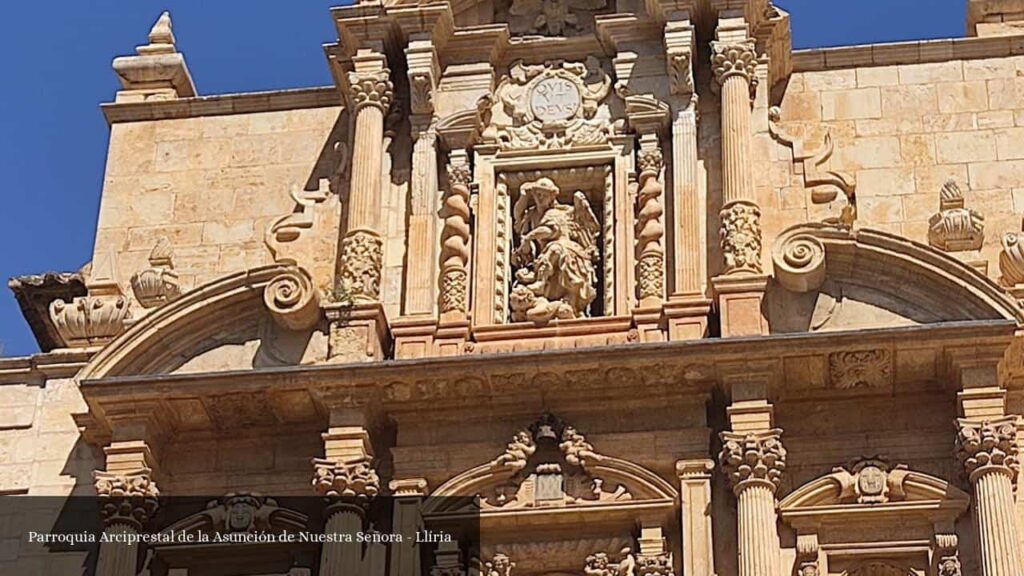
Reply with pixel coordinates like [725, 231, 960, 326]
[760, 56, 1024, 279]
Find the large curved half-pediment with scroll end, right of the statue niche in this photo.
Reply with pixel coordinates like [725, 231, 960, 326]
[768, 224, 1024, 333]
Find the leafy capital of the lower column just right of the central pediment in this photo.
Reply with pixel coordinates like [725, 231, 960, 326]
[719, 428, 785, 494]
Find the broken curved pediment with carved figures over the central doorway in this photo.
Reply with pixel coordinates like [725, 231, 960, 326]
[424, 415, 678, 515]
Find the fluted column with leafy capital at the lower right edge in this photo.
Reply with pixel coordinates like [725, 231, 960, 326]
[956, 416, 1024, 576]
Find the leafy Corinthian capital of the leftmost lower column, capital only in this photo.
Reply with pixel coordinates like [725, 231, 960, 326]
[92, 468, 160, 530]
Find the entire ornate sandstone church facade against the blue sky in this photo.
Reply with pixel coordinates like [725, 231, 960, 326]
[6, 0, 1024, 576]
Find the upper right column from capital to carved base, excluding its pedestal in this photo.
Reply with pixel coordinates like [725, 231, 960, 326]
[712, 39, 762, 274]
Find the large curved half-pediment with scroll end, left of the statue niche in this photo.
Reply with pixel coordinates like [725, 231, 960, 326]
[79, 263, 319, 380]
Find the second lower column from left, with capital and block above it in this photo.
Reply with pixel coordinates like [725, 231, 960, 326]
[312, 426, 380, 576]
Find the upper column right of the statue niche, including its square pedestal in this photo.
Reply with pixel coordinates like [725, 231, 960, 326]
[712, 18, 768, 336]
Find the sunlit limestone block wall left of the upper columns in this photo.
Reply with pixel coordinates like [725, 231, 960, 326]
[94, 107, 341, 301]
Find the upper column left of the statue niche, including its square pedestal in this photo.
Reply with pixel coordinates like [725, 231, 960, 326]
[325, 49, 393, 363]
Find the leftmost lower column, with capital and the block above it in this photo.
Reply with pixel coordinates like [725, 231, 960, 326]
[93, 442, 160, 576]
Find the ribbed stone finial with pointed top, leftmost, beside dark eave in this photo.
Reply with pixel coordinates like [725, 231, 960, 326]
[50, 252, 131, 347]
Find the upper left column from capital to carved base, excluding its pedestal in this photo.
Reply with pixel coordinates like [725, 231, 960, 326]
[339, 54, 393, 303]
